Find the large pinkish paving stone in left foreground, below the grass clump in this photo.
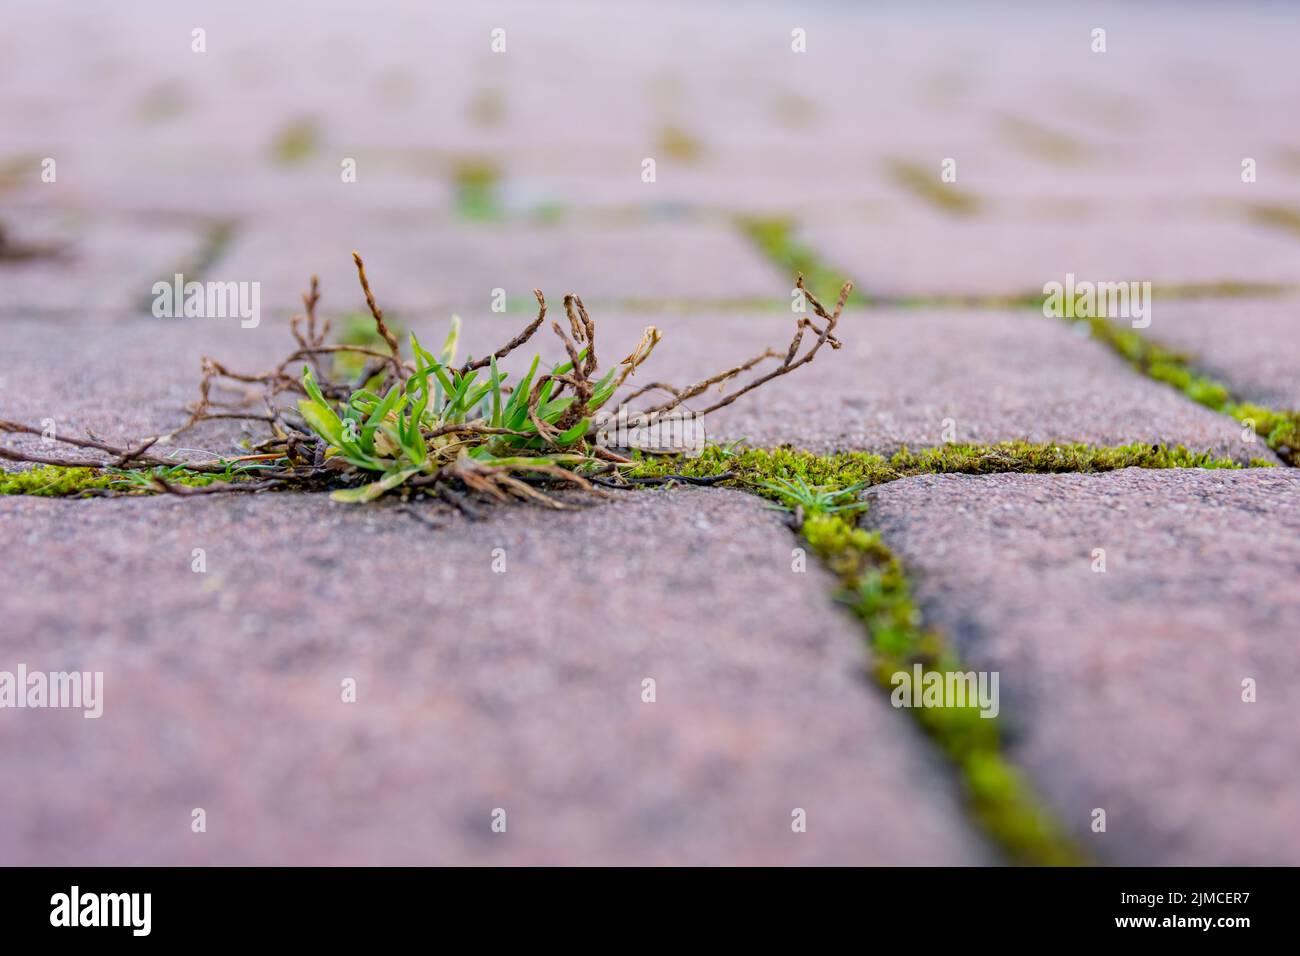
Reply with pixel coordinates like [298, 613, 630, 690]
[0, 489, 991, 864]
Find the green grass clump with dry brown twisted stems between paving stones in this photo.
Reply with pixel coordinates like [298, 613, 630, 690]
[0, 252, 852, 514]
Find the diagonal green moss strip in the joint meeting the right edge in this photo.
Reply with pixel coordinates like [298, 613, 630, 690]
[1075, 317, 1300, 466]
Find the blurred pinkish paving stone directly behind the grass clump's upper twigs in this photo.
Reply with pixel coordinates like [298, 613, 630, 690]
[217, 217, 788, 316]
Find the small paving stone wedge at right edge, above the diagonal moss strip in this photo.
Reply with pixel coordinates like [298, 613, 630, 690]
[1128, 298, 1300, 408]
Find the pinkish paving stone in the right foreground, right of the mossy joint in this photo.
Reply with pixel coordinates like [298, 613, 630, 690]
[867, 470, 1300, 865]
